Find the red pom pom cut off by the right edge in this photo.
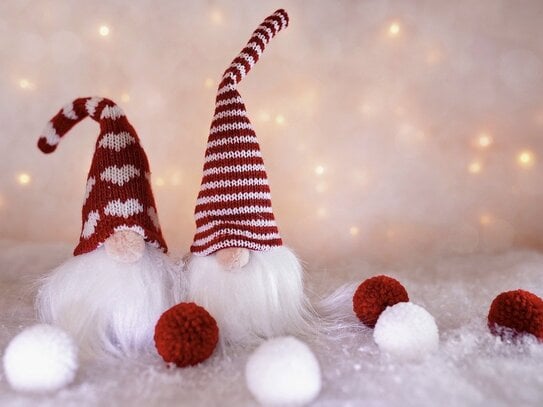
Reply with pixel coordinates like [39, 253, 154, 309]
[488, 290, 543, 341]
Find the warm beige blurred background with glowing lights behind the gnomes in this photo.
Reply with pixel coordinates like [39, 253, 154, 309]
[0, 0, 543, 264]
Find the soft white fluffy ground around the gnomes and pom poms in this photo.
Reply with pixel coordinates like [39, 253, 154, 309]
[0, 241, 543, 406]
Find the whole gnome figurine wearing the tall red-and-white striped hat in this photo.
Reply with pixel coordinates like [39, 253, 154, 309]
[186, 10, 312, 345]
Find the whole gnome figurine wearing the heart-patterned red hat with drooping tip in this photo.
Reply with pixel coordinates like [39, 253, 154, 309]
[36, 97, 182, 356]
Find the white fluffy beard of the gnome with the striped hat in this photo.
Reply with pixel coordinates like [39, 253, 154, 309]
[186, 246, 314, 345]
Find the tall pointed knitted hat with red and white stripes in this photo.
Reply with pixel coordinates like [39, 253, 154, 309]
[190, 10, 288, 256]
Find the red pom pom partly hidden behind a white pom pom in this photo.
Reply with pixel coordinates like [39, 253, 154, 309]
[353, 276, 409, 328]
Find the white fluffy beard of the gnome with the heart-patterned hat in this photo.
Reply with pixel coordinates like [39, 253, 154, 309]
[36, 244, 185, 357]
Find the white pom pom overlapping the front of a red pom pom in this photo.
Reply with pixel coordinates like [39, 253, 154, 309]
[373, 302, 439, 360]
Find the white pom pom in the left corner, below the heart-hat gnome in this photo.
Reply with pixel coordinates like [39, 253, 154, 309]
[4, 324, 78, 392]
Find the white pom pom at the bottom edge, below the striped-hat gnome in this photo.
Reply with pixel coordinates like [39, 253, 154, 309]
[245, 336, 321, 405]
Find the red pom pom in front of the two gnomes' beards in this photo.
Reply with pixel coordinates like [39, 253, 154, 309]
[155, 302, 219, 367]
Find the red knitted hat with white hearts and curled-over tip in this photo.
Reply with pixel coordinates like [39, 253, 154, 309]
[38, 97, 167, 256]
